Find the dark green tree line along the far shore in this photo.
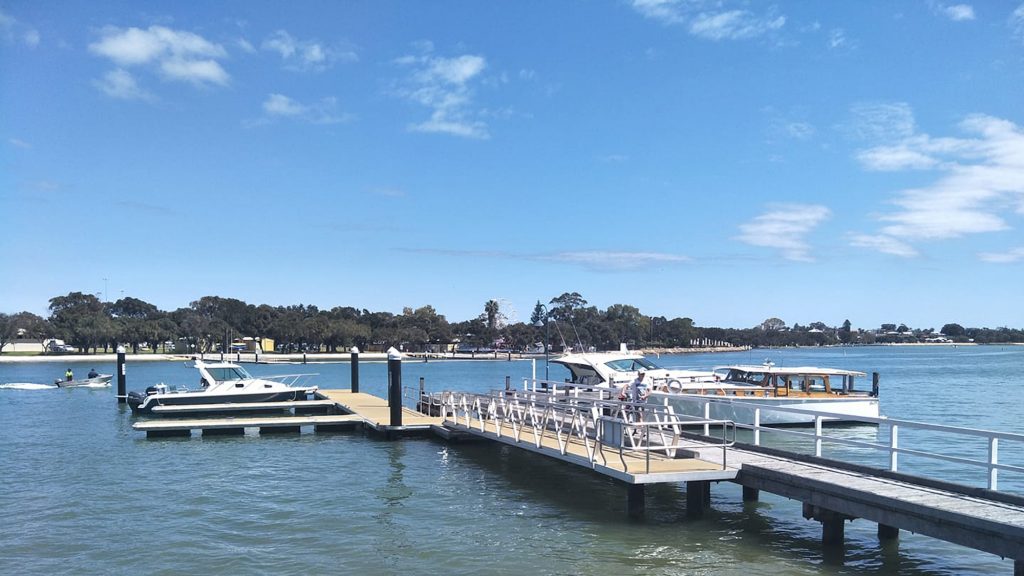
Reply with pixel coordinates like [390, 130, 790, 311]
[0, 292, 1024, 354]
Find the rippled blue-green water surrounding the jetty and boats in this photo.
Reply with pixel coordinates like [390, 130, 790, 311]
[0, 346, 1024, 575]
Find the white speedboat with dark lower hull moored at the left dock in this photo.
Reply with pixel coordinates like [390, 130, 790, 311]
[128, 360, 316, 414]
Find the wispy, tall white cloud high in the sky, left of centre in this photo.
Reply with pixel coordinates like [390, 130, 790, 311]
[395, 46, 489, 138]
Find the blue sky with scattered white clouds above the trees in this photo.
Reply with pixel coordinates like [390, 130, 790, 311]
[0, 0, 1024, 328]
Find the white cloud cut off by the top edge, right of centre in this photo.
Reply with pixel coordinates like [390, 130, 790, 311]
[632, 0, 785, 41]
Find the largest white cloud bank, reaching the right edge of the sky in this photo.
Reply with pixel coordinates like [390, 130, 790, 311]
[858, 115, 1024, 247]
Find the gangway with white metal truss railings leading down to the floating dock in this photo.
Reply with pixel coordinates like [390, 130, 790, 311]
[432, 389, 735, 474]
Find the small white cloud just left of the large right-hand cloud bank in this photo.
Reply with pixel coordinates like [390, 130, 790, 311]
[736, 204, 831, 261]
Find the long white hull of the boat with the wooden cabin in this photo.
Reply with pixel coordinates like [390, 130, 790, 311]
[651, 394, 879, 426]
